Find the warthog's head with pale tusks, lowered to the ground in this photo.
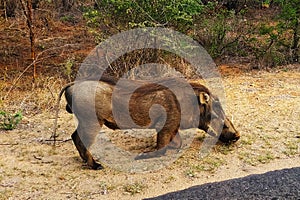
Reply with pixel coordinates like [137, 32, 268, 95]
[199, 88, 240, 143]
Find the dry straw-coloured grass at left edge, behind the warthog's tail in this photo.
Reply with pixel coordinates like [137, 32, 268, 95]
[0, 75, 66, 115]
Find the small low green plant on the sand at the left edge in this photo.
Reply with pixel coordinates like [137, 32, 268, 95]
[0, 111, 23, 130]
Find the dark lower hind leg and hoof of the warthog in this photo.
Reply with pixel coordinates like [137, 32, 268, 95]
[72, 130, 103, 169]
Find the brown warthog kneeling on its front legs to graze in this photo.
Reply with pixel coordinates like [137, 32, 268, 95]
[54, 78, 240, 169]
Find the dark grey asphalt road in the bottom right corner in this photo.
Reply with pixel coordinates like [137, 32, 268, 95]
[148, 167, 300, 200]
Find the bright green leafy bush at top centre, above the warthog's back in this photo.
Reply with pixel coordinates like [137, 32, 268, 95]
[84, 0, 204, 32]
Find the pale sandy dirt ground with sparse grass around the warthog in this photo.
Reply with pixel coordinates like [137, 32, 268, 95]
[0, 69, 300, 200]
